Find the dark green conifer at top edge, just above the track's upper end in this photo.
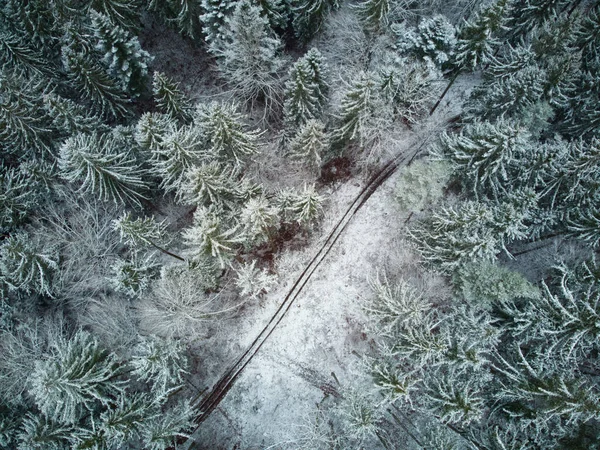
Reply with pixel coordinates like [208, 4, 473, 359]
[453, 0, 509, 70]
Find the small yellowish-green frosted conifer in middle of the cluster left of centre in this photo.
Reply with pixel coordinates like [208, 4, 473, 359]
[177, 162, 235, 206]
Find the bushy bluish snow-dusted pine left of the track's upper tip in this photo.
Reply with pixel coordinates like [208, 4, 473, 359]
[393, 15, 456, 67]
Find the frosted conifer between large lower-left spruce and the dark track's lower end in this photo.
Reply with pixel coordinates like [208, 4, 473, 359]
[130, 337, 187, 398]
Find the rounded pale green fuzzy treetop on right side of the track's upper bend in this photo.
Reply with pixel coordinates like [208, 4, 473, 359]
[396, 160, 450, 211]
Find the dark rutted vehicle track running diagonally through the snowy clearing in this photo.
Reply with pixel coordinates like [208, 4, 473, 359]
[187, 125, 446, 448]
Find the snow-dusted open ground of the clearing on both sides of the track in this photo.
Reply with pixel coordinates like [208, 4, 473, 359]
[180, 80, 470, 450]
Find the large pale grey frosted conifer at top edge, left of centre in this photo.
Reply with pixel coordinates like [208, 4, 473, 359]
[211, 1, 283, 115]
